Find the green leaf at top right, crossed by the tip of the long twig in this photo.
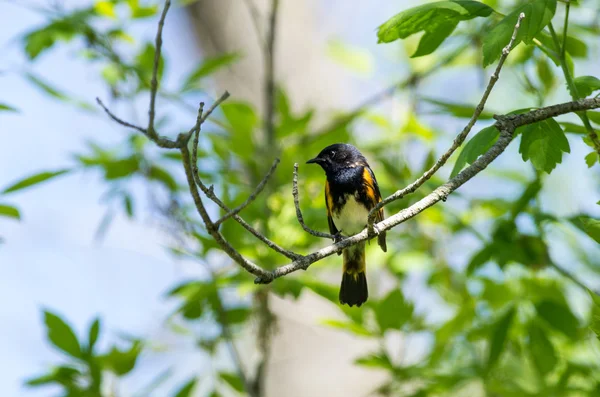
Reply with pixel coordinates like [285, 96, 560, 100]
[483, 0, 556, 67]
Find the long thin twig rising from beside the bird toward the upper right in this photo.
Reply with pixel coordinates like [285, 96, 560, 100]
[367, 13, 525, 230]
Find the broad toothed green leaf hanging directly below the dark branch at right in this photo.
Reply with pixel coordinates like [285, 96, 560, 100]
[519, 119, 571, 174]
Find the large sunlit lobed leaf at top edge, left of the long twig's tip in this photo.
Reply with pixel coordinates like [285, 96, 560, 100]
[377, 0, 493, 57]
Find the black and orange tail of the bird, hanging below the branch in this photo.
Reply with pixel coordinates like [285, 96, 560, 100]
[340, 242, 369, 307]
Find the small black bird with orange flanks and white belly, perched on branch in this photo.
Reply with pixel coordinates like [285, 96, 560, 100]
[306, 143, 387, 307]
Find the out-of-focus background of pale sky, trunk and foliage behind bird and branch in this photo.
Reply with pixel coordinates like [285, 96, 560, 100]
[0, 0, 600, 396]
